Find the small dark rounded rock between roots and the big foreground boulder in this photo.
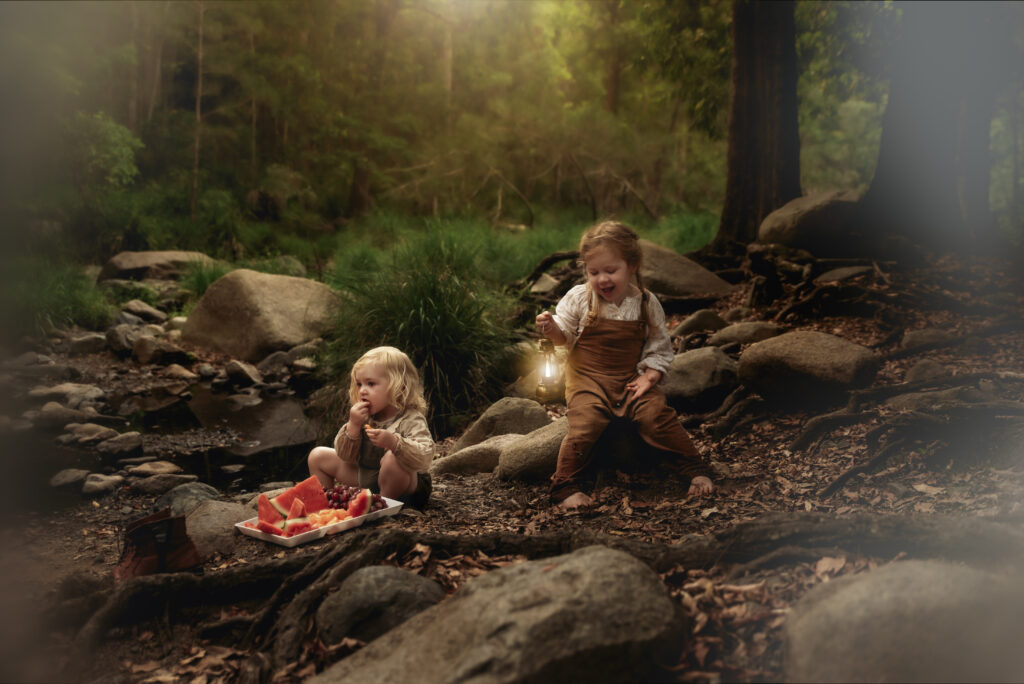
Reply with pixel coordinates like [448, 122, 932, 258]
[316, 565, 444, 644]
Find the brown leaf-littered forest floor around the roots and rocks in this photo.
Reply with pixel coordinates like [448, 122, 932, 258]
[0, 252, 1024, 682]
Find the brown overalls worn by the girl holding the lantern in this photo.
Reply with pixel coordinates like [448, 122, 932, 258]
[551, 317, 708, 502]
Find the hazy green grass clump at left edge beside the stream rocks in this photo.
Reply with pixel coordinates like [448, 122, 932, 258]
[0, 258, 115, 339]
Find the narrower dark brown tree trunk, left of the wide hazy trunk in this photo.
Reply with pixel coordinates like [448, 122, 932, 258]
[711, 0, 801, 253]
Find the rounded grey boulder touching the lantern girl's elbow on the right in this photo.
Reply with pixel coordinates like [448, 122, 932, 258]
[660, 347, 739, 413]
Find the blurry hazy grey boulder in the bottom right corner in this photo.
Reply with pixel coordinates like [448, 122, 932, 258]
[782, 560, 1024, 682]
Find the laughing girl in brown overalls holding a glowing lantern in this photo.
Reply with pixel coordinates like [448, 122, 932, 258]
[537, 221, 714, 508]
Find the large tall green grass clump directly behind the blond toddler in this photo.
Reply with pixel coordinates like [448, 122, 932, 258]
[327, 232, 510, 434]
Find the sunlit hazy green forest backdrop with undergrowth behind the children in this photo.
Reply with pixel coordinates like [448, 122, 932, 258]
[0, 0, 1024, 430]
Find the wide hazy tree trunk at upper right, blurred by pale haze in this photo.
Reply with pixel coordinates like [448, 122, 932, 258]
[857, 2, 1010, 251]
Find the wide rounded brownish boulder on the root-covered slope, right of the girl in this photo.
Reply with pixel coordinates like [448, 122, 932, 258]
[739, 330, 880, 405]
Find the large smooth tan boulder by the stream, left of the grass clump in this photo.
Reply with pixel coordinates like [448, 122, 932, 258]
[181, 268, 340, 362]
